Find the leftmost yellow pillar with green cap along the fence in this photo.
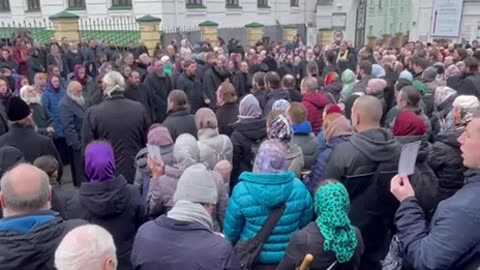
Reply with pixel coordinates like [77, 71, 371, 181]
[49, 11, 80, 42]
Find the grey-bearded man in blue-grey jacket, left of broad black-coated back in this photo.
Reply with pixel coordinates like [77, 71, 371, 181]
[59, 81, 85, 187]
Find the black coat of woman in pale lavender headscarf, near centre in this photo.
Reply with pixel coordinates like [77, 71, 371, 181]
[230, 118, 267, 190]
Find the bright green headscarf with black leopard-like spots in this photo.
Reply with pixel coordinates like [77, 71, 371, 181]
[315, 183, 358, 263]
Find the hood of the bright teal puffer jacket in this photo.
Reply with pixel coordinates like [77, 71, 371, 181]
[240, 171, 295, 208]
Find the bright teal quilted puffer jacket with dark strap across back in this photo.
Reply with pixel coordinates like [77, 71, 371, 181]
[224, 172, 313, 264]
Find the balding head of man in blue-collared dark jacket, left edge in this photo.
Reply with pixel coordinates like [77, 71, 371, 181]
[0, 164, 51, 217]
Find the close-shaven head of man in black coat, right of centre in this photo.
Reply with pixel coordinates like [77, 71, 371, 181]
[351, 96, 383, 132]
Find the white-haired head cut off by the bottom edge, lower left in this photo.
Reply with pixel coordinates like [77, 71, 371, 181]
[55, 225, 118, 270]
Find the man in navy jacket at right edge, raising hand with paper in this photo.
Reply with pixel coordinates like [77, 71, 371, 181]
[390, 111, 480, 270]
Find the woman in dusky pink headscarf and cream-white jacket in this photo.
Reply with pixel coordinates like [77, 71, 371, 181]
[195, 108, 233, 170]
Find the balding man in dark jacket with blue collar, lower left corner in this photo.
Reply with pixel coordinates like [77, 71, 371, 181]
[0, 163, 86, 270]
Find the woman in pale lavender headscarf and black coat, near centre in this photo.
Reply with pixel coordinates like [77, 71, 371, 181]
[230, 94, 267, 190]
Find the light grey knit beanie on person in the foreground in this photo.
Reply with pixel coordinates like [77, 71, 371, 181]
[173, 163, 218, 204]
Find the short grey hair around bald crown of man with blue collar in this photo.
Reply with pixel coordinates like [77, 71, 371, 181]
[0, 163, 50, 213]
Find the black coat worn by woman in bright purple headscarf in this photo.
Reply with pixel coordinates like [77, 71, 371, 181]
[70, 176, 145, 270]
